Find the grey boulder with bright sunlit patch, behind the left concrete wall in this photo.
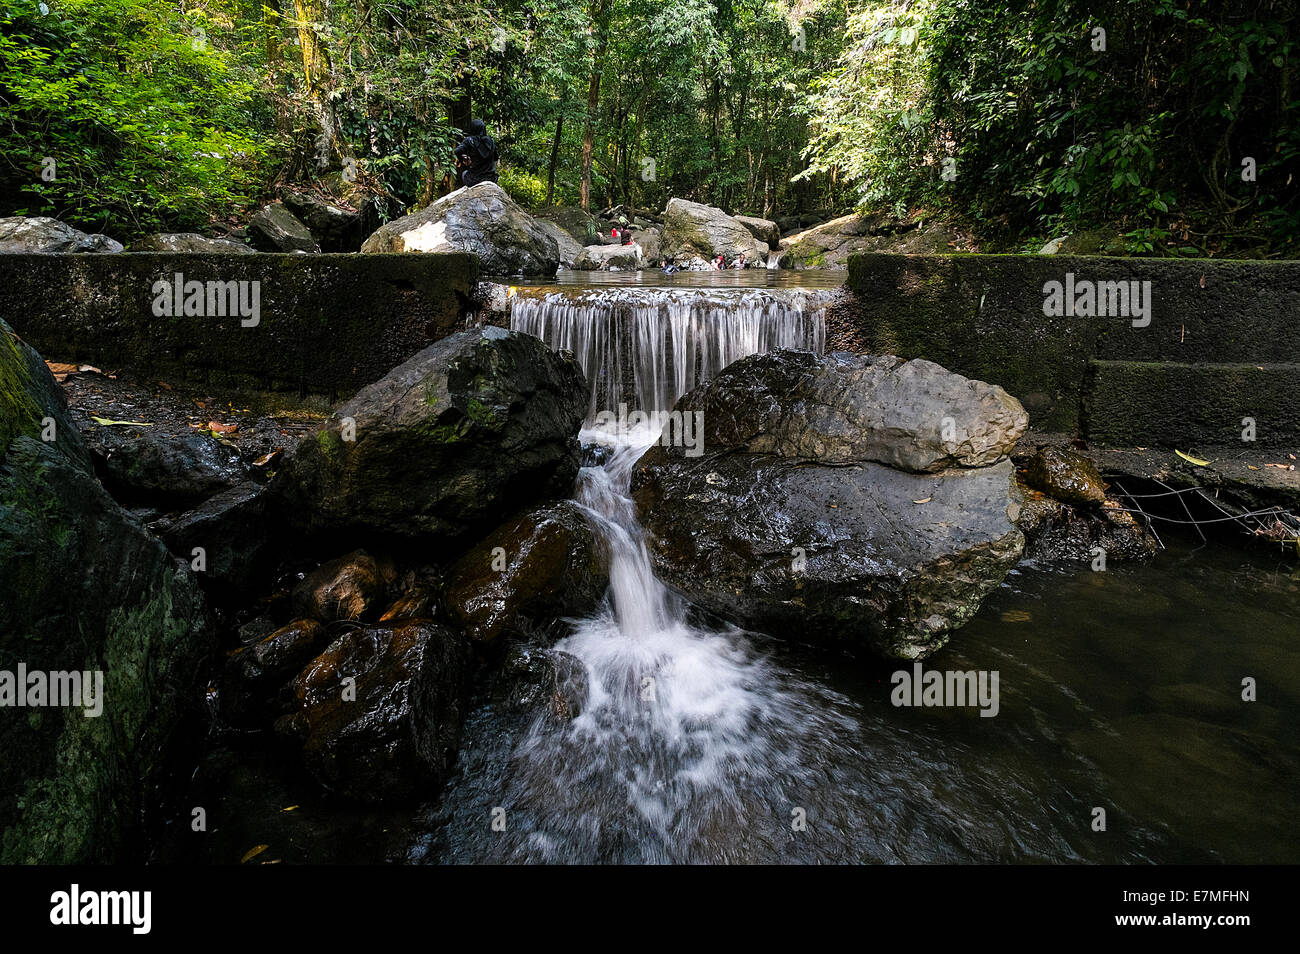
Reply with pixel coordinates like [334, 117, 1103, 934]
[361, 182, 560, 276]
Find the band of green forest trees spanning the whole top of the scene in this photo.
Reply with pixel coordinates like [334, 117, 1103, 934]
[0, 0, 1300, 255]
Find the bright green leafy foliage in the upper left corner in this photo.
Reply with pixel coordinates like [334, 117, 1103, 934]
[0, 0, 264, 231]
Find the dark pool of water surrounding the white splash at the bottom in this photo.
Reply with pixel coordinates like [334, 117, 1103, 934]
[169, 546, 1300, 863]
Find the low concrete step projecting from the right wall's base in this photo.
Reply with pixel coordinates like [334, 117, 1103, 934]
[1083, 361, 1300, 450]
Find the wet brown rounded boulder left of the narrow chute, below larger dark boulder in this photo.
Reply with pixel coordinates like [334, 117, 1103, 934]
[445, 500, 610, 642]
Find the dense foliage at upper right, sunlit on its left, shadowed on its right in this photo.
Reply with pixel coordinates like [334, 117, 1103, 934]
[810, 0, 1300, 255]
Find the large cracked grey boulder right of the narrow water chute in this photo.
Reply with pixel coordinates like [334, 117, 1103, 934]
[633, 351, 1027, 659]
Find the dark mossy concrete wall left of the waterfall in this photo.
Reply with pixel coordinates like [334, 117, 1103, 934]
[0, 252, 478, 395]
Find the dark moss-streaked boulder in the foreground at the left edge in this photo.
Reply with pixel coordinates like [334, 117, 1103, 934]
[0, 321, 212, 864]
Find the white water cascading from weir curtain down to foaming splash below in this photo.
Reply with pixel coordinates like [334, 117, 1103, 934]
[460, 278, 858, 863]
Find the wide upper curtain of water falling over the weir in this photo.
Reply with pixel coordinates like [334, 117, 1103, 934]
[510, 287, 833, 419]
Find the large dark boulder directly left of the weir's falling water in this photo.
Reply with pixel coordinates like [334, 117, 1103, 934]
[272, 326, 588, 543]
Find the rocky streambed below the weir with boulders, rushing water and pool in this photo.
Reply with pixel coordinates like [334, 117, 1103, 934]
[0, 295, 1296, 863]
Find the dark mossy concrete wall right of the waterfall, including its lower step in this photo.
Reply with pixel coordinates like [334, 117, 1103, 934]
[840, 253, 1300, 446]
